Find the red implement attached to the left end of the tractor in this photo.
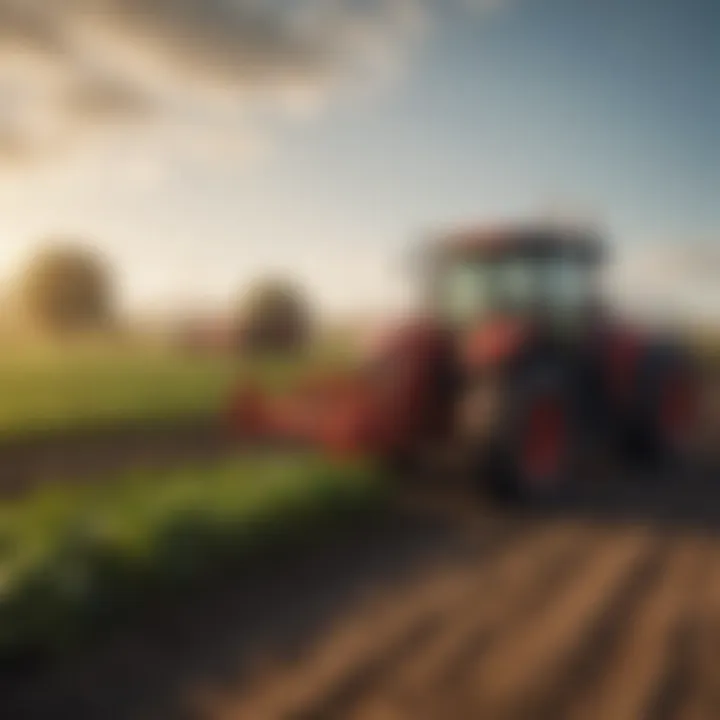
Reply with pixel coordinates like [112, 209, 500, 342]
[230, 323, 446, 456]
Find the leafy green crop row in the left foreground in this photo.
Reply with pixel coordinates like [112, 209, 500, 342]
[0, 458, 384, 657]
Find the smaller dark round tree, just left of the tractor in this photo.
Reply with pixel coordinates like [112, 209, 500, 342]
[236, 278, 311, 353]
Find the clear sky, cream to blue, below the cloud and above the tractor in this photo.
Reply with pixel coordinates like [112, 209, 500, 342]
[0, 0, 720, 316]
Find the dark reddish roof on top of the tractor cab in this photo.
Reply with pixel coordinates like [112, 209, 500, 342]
[434, 225, 606, 262]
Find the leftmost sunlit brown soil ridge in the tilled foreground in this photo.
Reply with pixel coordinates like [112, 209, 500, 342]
[202, 526, 568, 718]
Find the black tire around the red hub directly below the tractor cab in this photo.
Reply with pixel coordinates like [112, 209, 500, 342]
[474, 359, 576, 504]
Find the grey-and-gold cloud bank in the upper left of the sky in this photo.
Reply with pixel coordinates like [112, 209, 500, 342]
[0, 0, 497, 161]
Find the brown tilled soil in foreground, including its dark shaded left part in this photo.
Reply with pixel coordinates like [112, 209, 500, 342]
[0, 458, 720, 720]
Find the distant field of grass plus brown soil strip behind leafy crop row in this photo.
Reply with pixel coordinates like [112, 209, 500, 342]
[0, 348, 346, 496]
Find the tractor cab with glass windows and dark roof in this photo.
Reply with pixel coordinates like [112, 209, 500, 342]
[426, 228, 604, 329]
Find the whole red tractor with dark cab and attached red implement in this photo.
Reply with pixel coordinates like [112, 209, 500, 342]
[231, 227, 696, 499]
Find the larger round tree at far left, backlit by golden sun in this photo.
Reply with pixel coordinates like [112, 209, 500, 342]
[20, 239, 113, 334]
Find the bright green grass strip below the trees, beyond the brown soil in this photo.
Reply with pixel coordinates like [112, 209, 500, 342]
[0, 352, 346, 439]
